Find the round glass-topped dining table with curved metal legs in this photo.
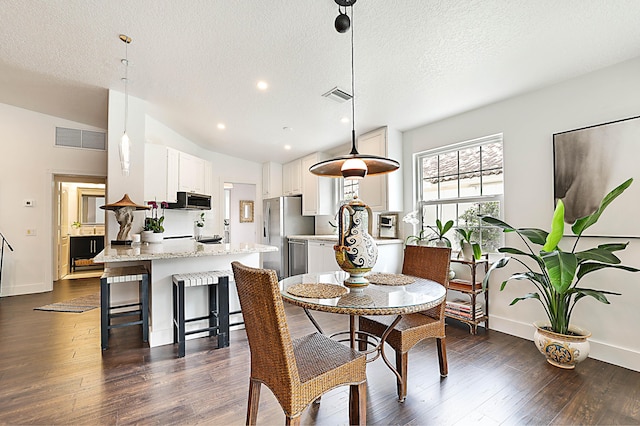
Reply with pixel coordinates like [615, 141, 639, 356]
[280, 271, 446, 388]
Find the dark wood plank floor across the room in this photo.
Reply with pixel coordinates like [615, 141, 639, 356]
[0, 279, 640, 425]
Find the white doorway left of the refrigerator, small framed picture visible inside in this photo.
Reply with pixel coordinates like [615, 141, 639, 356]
[223, 182, 260, 243]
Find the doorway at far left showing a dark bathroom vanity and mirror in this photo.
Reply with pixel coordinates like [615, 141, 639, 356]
[53, 175, 106, 281]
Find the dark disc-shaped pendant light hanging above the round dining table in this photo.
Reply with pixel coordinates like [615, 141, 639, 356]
[309, 0, 400, 179]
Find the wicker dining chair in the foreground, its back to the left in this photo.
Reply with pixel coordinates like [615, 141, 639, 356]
[231, 262, 367, 425]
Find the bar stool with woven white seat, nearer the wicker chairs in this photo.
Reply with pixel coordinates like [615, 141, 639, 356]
[173, 271, 231, 357]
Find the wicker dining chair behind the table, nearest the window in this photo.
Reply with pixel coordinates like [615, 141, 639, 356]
[359, 246, 451, 401]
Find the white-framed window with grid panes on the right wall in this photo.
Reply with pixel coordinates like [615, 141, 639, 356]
[415, 134, 504, 253]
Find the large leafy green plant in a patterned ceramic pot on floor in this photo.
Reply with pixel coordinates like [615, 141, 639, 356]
[482, 179, 639, 368]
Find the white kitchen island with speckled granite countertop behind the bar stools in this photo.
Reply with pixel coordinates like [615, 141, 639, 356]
[93, 239, 277, 347]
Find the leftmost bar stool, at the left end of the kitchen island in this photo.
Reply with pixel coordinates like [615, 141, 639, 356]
[100, 265, 149, 350]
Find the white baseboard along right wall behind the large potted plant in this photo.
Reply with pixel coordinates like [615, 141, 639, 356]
[489, 315, 640, 371]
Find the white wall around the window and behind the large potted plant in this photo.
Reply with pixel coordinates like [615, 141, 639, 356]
[403, 55, 640, 371]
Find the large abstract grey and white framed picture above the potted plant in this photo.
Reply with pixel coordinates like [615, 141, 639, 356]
[553, 117, 640, 238]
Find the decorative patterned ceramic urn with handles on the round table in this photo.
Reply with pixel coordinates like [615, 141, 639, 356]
[333, 197, 378, 291]
